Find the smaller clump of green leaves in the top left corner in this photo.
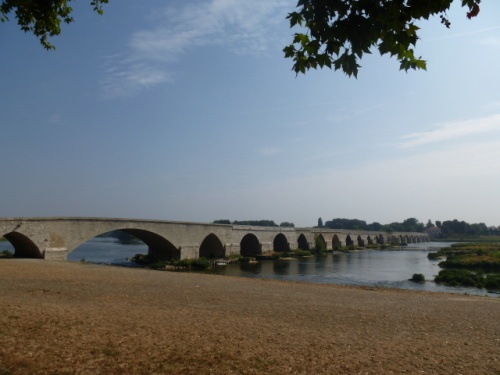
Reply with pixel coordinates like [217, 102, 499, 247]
[0, 0, 109, 50]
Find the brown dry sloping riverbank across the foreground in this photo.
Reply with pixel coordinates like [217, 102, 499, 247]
[0, 259, 500, 374]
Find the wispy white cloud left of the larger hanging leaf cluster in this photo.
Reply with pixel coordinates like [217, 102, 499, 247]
[103, 0, 290, 97]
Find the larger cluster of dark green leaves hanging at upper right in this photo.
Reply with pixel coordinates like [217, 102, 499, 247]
[283, 0, 480, 77]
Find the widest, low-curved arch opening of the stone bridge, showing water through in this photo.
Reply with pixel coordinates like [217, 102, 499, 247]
[68, 228, 180, 265]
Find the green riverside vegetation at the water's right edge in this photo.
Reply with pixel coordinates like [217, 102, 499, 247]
[427, 243, 500, 291]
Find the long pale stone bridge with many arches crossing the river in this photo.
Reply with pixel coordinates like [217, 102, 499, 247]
[0, 217, 428, 260]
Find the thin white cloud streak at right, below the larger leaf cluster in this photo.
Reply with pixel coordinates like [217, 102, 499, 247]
[399, 114, 500, 148]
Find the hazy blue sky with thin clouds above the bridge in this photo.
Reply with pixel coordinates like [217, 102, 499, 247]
[0, 0, 500, 226]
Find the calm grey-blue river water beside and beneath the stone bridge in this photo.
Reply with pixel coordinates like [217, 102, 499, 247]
[0, 237, 500, 297]
